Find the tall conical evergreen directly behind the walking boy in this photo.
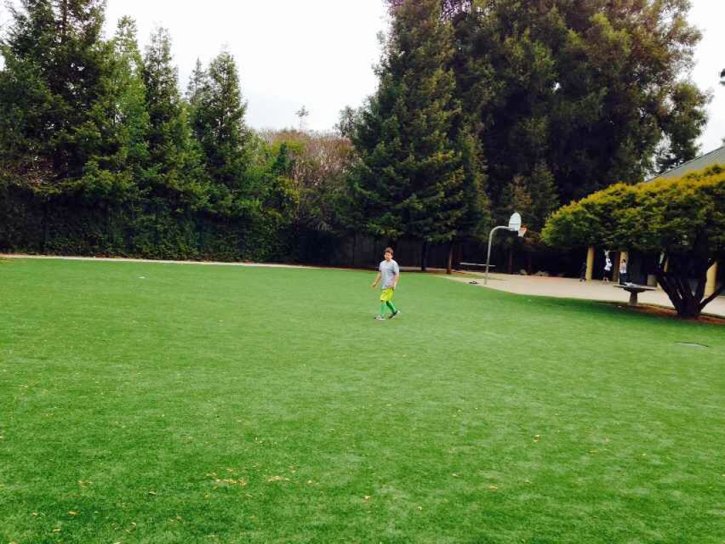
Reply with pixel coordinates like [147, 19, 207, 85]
[352, 0, 465, 270]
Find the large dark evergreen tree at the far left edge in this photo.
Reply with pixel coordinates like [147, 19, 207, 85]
[0, 0, 116, 192]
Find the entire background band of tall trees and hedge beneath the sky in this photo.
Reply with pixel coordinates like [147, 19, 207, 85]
[0, 0, 708, 265]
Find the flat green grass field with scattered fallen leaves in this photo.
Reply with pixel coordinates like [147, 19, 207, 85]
[0, 260, 725, 544]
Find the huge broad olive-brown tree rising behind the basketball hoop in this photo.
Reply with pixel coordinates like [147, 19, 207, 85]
[451, 0, 707, 211]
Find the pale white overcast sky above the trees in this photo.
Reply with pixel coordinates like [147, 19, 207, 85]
[1, 0, 725, 152]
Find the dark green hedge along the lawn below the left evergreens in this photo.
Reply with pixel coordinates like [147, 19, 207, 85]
[0, 186, 303, 261]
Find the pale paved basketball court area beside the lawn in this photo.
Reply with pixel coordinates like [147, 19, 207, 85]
[447, 274, 725, 317]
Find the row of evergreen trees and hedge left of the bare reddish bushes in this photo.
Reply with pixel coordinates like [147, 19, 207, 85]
[0, 4, 320, 266]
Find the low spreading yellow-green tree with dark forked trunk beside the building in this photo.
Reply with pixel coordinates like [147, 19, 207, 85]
[543, 166, 725, 318]
